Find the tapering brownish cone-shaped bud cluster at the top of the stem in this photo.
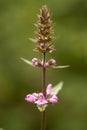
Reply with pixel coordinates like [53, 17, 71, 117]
[31, 5, 55, 53]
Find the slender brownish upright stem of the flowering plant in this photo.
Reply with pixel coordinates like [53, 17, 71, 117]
[41, 53, 46, 130]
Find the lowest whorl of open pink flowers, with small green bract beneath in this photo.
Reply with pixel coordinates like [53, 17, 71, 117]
[25, 84, 58, 111]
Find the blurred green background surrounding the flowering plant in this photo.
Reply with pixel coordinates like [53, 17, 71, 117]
[0, 0, 87, 130]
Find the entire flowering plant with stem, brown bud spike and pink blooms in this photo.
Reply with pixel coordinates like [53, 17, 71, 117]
[21, 5, 69, 130]
